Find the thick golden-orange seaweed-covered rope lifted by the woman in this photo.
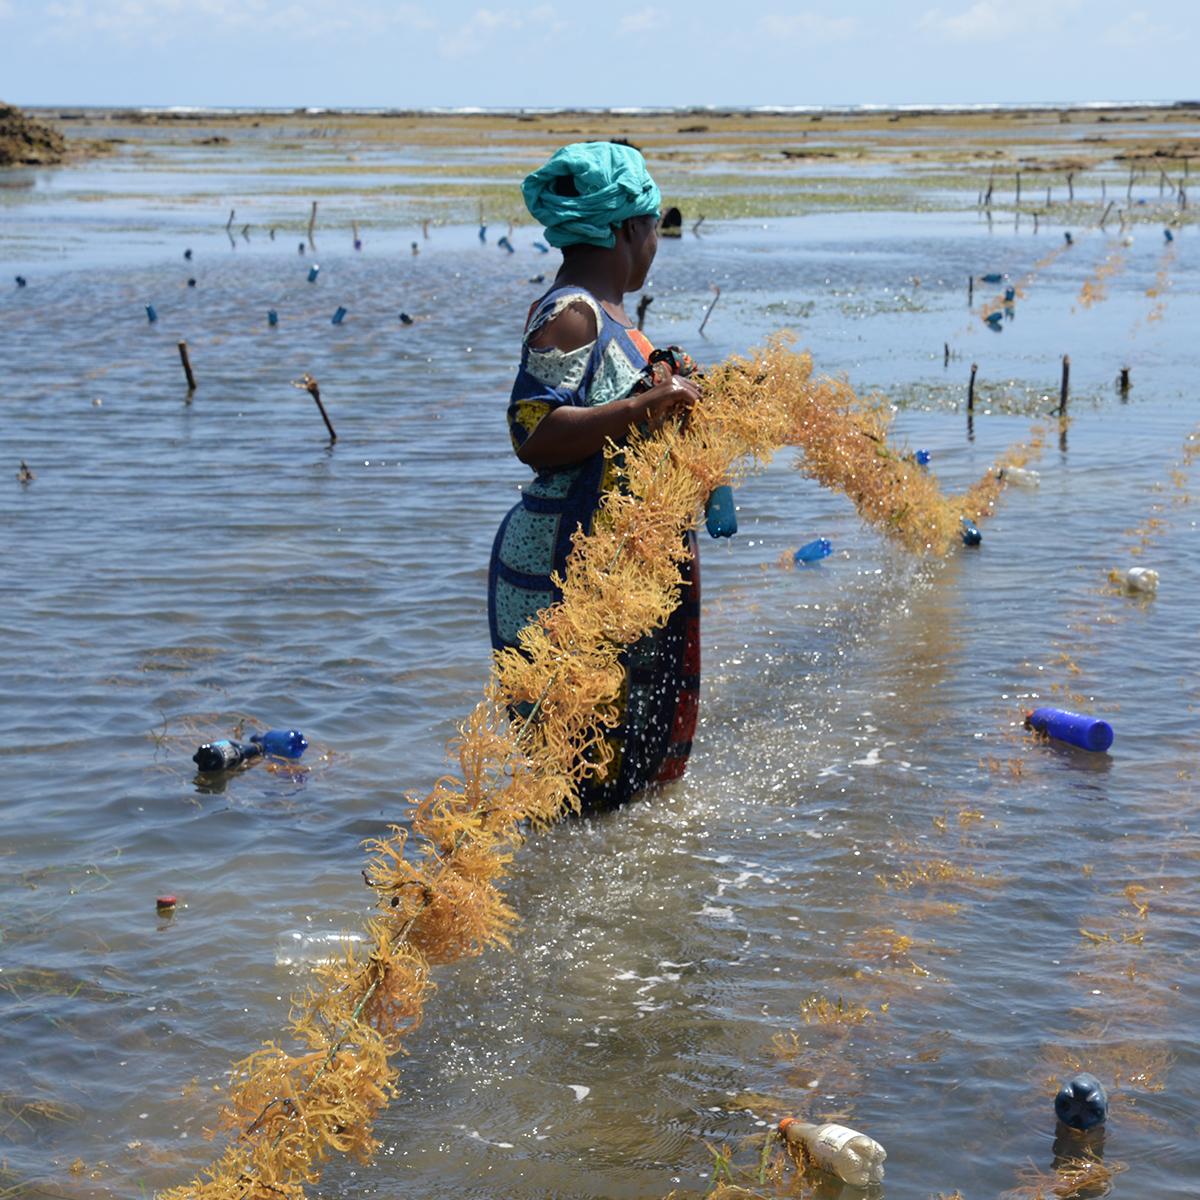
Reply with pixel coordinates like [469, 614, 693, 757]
[164, 335, 1041, 1200]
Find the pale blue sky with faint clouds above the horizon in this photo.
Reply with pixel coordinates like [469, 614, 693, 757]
[0, 0, 1200, 108]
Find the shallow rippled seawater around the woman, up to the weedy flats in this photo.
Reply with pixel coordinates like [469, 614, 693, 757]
[0, 124, 1200, 1200]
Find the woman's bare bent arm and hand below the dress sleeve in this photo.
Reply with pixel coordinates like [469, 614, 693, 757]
[517, 376, 700, 470]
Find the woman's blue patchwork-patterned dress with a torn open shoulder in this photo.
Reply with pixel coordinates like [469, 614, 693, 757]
[487, 288, 700, 811]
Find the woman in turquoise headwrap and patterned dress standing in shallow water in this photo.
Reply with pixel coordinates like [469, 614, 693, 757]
[487, 142, 700, 810]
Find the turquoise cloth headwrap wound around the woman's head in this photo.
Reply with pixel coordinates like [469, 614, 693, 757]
[521, 142, 662, 247]
